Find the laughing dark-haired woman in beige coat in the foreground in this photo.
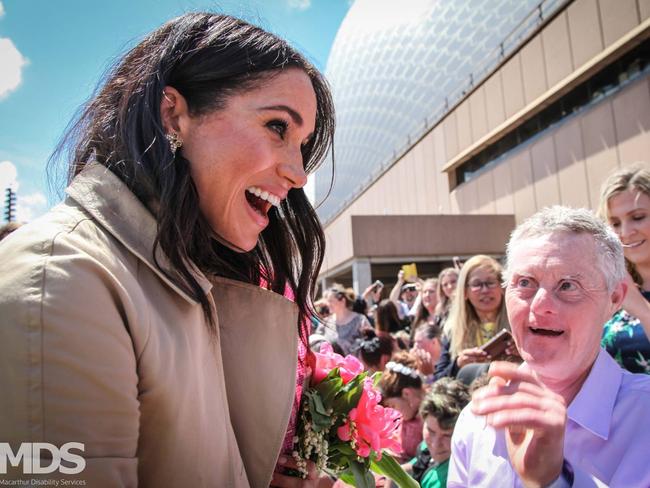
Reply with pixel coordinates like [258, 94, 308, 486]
[0, 13, 334, 487]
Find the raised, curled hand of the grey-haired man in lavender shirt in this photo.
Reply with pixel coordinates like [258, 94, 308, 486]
[472, 362, 567, 488]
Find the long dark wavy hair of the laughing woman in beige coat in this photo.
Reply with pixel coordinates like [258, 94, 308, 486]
[50, 13, 334, 342]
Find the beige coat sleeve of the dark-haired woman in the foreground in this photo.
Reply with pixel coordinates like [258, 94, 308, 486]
[0, 232, 140, 487]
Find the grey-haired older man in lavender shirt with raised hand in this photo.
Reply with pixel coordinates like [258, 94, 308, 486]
[447, 207, 650, 488]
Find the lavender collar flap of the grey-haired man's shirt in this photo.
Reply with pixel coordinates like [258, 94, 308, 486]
[567, 349, 623, 440]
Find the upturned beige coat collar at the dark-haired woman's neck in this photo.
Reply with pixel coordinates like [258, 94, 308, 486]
[66, 163, 212, 304]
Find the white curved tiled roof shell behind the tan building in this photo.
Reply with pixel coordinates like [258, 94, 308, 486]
[316, 0, 561, 221]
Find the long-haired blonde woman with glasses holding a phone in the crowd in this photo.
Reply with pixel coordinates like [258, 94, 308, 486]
[435, 255, 512, 378]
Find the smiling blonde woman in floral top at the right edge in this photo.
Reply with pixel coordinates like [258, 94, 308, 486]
[600, 164, 650, 374]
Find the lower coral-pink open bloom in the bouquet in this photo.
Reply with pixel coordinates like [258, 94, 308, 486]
[337, 379, 401, 459]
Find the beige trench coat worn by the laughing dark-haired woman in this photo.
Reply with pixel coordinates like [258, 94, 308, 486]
[0, 165, 298, 488]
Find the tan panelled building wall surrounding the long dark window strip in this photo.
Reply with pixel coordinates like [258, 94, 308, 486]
[323, 0, 650, 272]
